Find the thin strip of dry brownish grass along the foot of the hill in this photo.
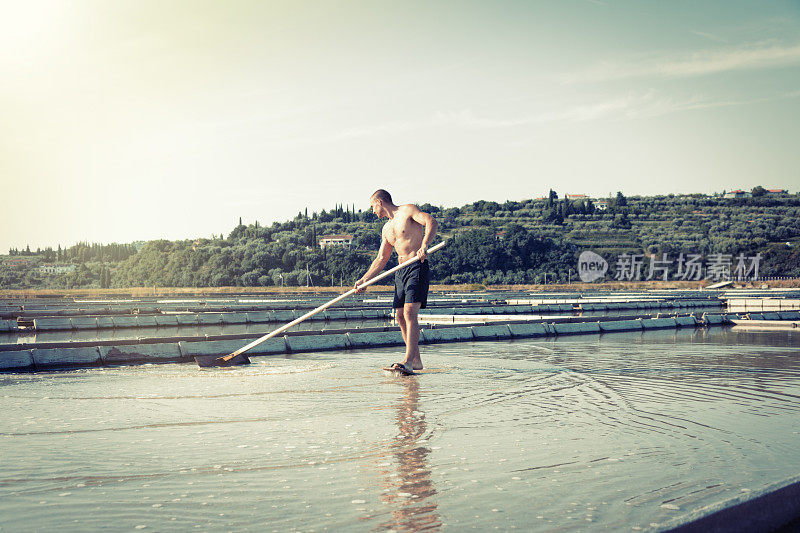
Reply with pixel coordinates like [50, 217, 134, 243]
[0, 279, 800, 298]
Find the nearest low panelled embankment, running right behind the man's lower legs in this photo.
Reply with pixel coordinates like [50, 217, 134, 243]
[0, 314, 738, 371]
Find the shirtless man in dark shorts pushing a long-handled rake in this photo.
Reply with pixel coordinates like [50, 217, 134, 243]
[355, 189, 438, 372]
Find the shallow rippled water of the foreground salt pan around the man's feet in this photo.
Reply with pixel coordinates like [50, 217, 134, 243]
[0, 328, 800, 531]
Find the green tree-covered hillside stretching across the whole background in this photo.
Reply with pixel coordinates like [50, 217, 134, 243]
[0, 190, 800, 288]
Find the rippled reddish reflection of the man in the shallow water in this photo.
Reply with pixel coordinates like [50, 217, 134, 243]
[375, 378, 442, 531]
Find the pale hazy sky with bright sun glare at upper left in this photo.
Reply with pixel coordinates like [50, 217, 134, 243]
[0, 0, 800, 253]
